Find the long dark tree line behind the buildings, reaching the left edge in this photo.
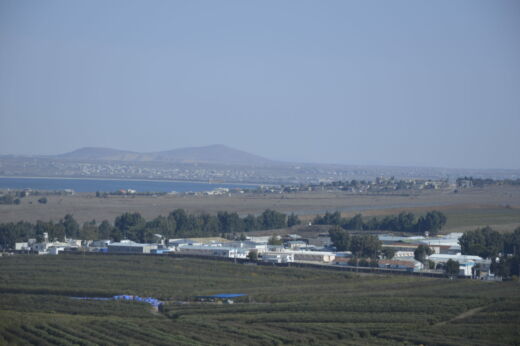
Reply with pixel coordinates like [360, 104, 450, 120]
[0, 209, 300, 249]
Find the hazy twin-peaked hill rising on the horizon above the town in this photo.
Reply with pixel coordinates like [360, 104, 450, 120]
[54, 144, 274, 166]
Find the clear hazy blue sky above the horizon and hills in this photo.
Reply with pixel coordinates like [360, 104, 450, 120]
[0, 0, 520, 168]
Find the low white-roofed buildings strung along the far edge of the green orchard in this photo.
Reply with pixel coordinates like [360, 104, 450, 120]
[11, 233, 492, 279]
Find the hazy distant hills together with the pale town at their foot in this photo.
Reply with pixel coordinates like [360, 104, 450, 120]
[0, 146, 520, 185]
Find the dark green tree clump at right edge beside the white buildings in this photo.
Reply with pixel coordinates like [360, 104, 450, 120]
[459, 227, 520, 277]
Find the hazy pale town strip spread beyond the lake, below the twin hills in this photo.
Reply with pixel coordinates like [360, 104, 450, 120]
[0, 156, 492, 189]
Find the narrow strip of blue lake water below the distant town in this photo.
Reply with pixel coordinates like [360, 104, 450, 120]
[0, 178, 257, 192]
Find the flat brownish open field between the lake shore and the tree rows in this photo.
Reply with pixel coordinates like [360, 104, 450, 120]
[0, 187, 520, 231]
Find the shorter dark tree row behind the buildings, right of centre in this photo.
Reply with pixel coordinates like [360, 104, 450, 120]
[313, 210, 447, 235]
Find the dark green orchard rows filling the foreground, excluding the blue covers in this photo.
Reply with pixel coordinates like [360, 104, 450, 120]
[0, 255, 520, 345]
